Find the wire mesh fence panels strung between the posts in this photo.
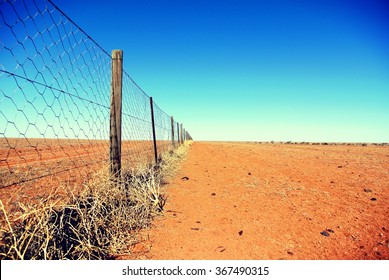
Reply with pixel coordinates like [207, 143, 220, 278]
[0, 0, 189, 194]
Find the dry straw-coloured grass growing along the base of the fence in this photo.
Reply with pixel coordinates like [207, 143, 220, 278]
[0, 142, 190, 260]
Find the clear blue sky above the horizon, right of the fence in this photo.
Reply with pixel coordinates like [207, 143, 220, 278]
[46, 0, 389, 142]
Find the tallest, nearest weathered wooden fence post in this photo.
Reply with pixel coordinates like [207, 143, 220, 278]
[109, 50, 123, 179]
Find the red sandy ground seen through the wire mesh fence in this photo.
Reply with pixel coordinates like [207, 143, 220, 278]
[0, 138, 171, 210]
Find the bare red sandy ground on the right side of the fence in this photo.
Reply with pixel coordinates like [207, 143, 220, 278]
[126, 142, 389, 260]
